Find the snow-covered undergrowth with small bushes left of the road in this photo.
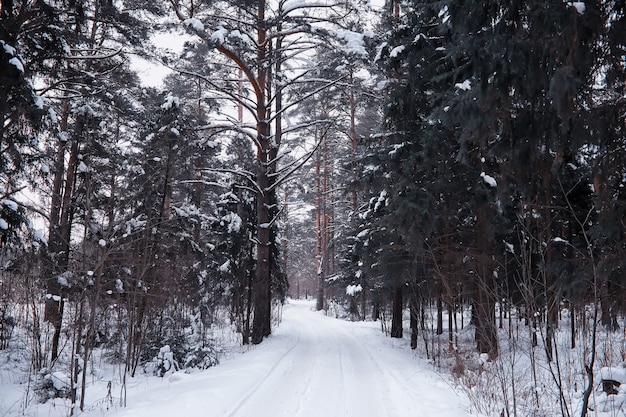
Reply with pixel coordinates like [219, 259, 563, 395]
[0, 306, 247, 417]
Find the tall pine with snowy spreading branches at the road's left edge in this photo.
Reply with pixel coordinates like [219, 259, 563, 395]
[166, 0, 366, 344]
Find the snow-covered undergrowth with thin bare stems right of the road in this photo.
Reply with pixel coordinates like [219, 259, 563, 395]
[405, 302, 626, 417]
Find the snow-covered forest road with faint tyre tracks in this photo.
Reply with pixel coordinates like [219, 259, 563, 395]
[108, 301, 478, 417]
